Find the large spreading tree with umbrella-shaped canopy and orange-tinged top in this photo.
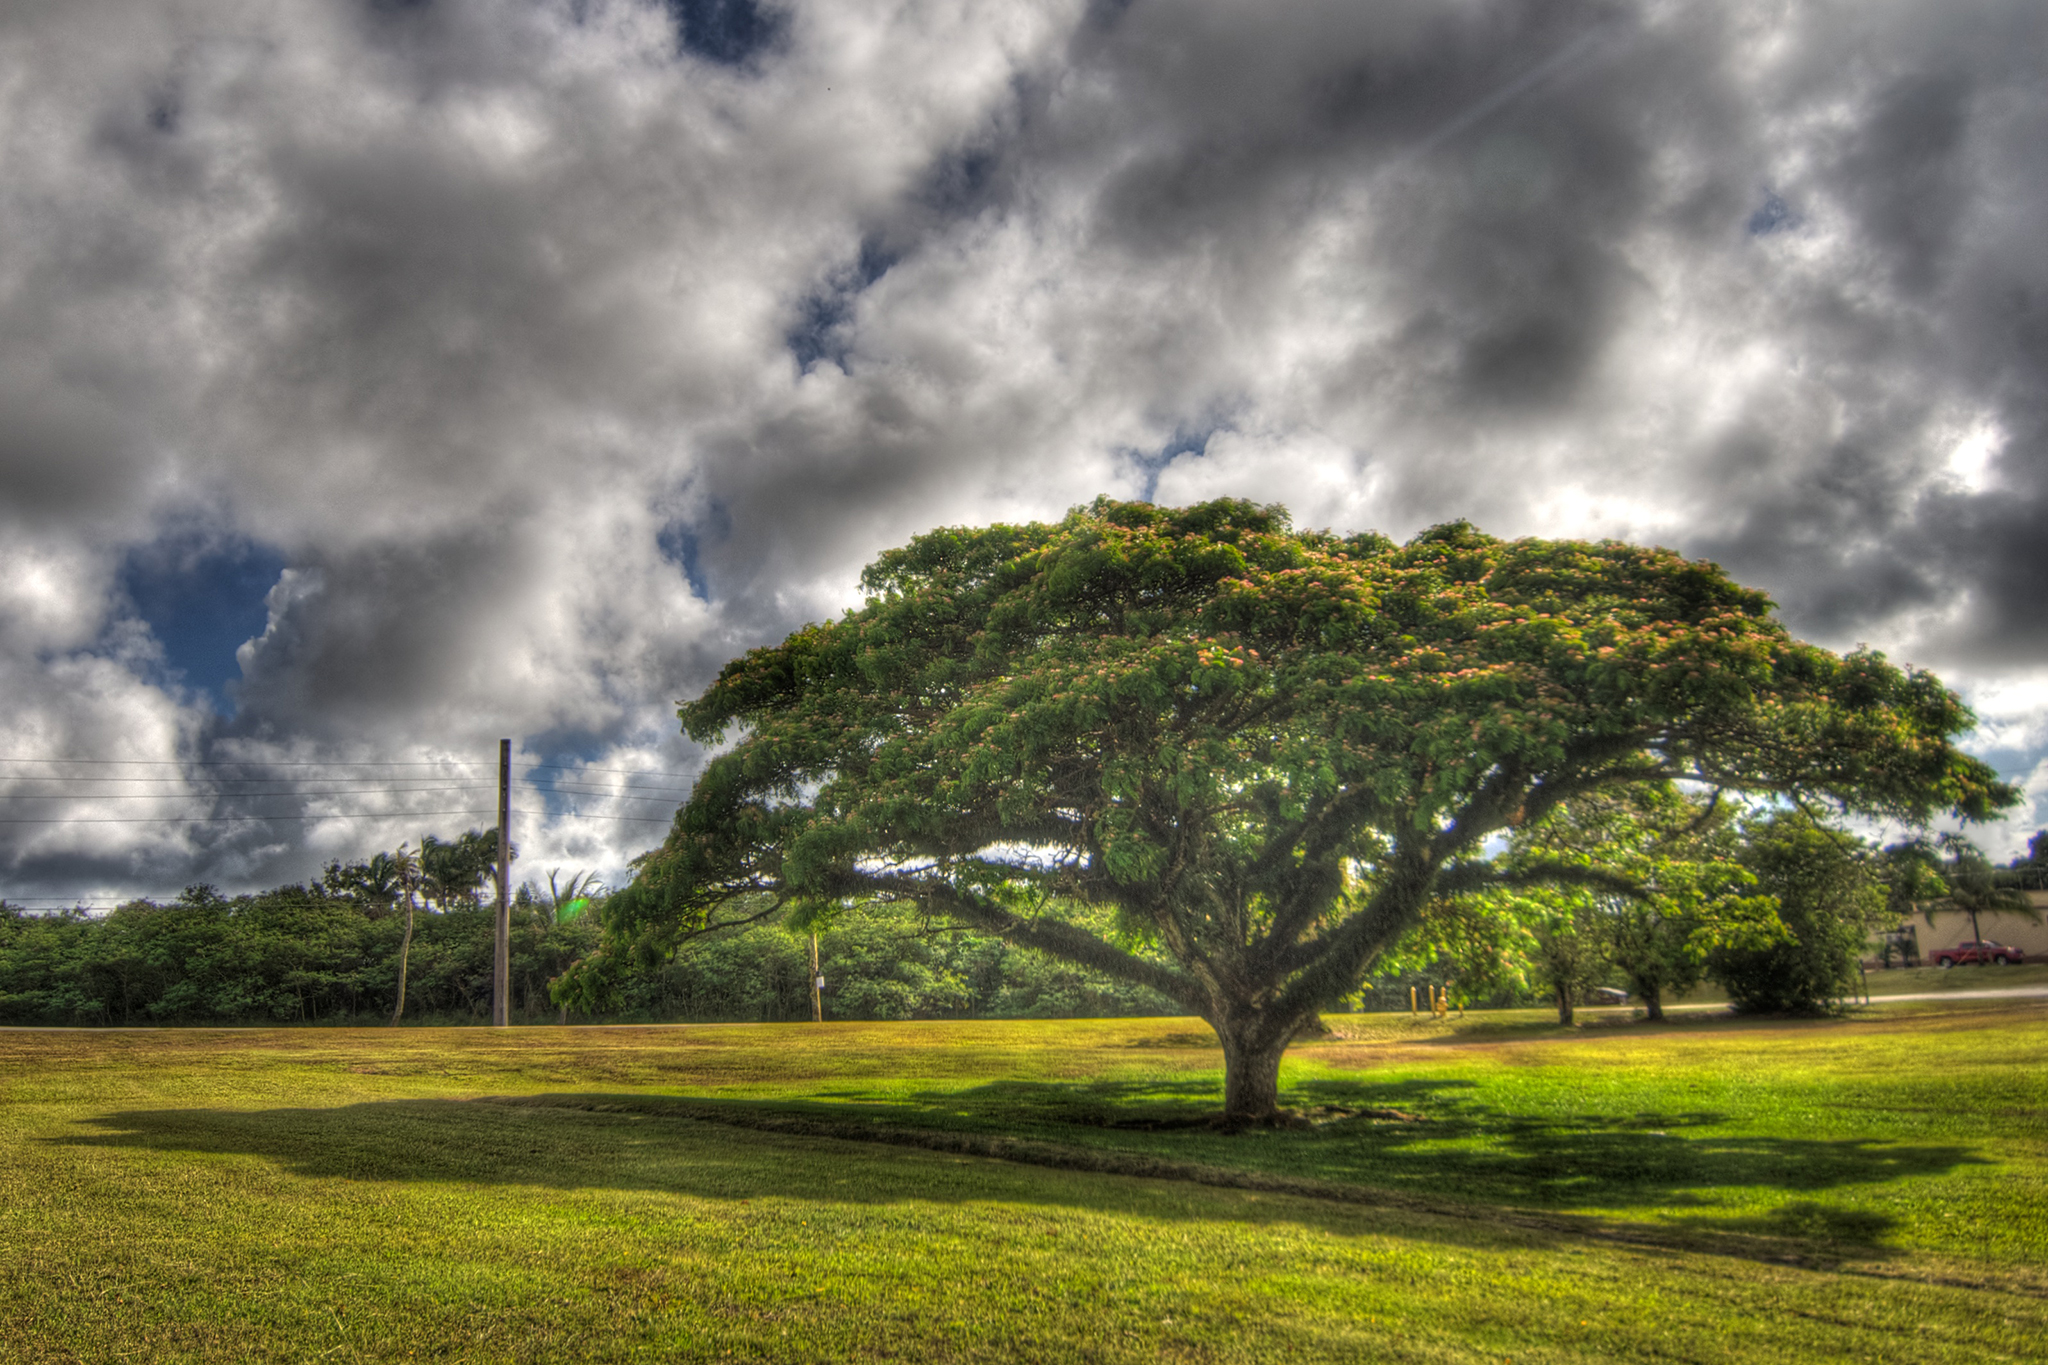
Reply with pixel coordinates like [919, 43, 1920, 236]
[606, 499, 2015, 1121]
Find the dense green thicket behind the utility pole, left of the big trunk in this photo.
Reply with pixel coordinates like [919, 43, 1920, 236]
[0, 884, 1180, 1025]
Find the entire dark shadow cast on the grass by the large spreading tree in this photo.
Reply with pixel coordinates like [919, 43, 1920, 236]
[51, 1081, 1987, 1261]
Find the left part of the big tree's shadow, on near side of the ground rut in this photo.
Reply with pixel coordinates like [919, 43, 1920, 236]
[41, 1093, 1561, 1246]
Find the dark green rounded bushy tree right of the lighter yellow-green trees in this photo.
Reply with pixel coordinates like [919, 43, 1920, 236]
[1708, 810, 1890, 1015]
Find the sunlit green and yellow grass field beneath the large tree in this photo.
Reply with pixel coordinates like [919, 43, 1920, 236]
[0, 997, 2048, 1365]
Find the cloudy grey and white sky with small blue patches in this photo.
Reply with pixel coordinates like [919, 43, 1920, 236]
[0, 0, 2048, 905]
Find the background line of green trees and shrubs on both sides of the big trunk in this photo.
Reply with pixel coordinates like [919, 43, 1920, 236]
[0, 810, 2048, 1025]
